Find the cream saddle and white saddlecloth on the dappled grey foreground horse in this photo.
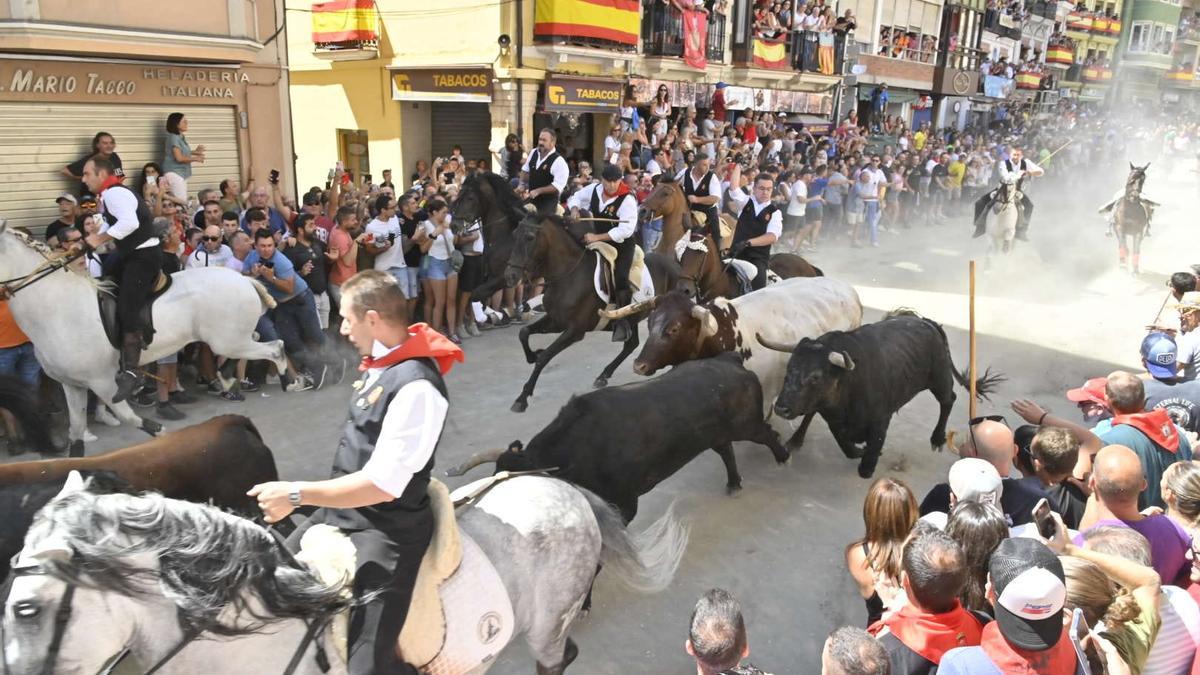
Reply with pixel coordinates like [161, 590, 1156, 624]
[296, 479, 514, 673]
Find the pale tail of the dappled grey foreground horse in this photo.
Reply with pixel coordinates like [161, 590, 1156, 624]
[578, 488, 689, 593]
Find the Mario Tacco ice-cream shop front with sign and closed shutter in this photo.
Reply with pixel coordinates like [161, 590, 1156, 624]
[0, 55, 283, 232]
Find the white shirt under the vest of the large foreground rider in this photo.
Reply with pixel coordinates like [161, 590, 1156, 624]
[359, 340, 450, 498]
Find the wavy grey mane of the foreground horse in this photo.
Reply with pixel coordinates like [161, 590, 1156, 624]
[30, 490, 348, 635]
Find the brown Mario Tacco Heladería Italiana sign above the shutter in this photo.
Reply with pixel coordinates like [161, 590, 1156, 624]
[0, 59, 250, 106]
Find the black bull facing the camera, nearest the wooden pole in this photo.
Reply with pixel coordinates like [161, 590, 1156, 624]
[758, 312, 1004, 478]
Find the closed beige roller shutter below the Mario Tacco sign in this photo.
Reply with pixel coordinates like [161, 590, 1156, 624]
[0, 102, 241, 233]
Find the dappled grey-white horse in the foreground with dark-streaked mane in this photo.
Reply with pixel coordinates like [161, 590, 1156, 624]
[0, 473, 688, 675]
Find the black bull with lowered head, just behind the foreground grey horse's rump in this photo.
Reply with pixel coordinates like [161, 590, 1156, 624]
[446, 354, 788, 522]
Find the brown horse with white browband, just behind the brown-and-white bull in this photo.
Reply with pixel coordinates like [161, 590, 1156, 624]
[676, 231, 824, 303]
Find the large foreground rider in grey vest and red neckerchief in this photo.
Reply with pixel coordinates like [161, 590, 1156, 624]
[247, 270, 463, 675]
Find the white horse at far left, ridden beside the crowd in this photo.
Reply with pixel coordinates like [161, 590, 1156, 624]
[0, 219, 287, 456]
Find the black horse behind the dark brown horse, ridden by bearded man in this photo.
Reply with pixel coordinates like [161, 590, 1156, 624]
[450, 172, 526, 305]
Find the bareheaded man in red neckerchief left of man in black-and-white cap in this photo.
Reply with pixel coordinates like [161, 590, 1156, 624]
[868, 530, 991, 675]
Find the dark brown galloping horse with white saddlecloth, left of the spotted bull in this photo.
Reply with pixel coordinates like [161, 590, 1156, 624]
[504, 215, 679, 412]
